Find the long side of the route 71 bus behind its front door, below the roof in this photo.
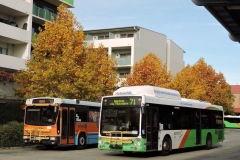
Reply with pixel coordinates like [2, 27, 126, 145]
[153, 104, 224, 155]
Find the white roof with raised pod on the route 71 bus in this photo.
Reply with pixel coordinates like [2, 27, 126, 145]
[110, 85, 223, 110]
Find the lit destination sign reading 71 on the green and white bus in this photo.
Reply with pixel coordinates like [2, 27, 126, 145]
[103, 97, 142, 106]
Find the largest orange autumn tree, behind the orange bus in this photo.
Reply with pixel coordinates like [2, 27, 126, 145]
[14, 5, 117, 101]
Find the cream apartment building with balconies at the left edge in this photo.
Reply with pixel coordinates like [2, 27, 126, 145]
[0, 0, 74, 103]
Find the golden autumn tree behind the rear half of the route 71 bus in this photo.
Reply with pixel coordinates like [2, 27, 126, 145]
[170, 58, 234, 111]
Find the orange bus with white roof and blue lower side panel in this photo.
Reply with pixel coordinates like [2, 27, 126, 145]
[23, 97, 100, 149]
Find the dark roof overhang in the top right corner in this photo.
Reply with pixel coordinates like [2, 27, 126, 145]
[192, 0, 240, 42]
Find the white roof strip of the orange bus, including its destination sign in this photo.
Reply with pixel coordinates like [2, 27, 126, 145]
[26, 97, 101, 107]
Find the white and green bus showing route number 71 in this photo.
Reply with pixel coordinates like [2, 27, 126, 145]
[98, 86, 224, 155]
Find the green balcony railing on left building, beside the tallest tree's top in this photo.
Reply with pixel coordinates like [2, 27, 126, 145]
[33, 5, 57, 21]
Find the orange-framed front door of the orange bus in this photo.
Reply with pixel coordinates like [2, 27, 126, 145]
[61, 107, 75, 144]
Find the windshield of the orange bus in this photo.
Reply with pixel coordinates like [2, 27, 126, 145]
[25, 106, 58, 126]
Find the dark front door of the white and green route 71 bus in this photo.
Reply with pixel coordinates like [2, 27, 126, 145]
[146, 108, 158, 150]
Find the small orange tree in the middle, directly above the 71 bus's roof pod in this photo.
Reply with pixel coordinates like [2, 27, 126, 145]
[122, 53, 172, 87]
